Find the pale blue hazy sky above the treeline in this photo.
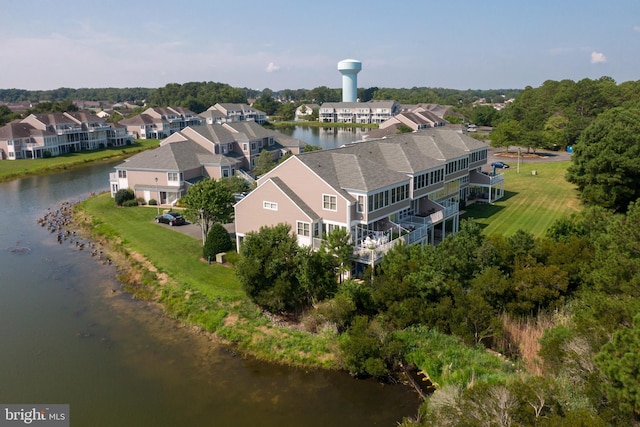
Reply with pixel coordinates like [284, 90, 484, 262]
[0, 0, 640, 90]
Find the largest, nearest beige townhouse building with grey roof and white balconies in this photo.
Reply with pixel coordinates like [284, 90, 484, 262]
[235, 128, 504, 271]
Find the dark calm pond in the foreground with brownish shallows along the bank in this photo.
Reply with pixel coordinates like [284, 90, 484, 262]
[0, 165, 418, 427]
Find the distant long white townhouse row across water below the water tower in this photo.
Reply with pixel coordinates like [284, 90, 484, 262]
[318, 101, 401, 124]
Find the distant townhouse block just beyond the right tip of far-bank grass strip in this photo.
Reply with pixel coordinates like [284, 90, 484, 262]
[119, 107, 203, 139]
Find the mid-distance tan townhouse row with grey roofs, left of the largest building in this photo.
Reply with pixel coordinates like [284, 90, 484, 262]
[109, 121, 304, 205]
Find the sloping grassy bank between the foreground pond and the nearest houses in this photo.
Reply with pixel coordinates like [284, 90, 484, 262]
[76, 193, 338, 368]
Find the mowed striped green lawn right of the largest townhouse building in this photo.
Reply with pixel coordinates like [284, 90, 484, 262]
[463, 161, 582, 236]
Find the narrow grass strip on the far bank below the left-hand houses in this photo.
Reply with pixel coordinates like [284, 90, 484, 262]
[0, 139, 159, 182]
